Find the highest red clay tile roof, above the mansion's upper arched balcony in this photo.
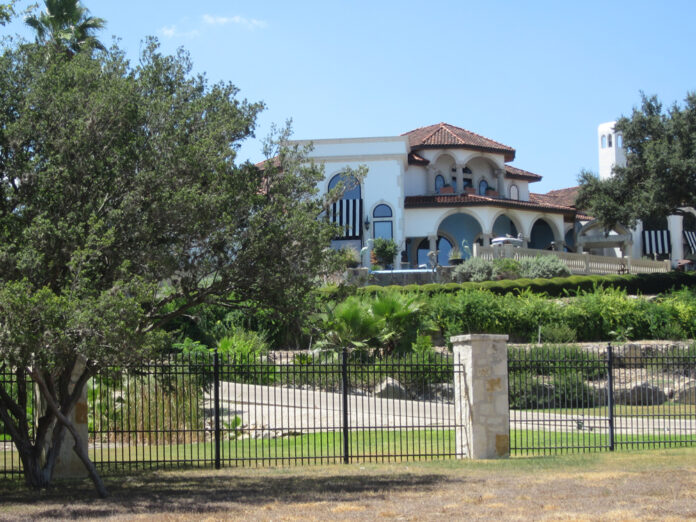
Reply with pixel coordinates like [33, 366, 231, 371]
[402, 123, 515, 161]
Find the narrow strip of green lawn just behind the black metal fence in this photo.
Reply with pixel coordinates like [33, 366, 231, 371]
[5, 422, 696, 476]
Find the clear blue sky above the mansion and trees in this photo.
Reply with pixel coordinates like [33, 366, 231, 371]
[5, 0, 696, 192]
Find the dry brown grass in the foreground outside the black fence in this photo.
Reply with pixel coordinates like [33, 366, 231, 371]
[0, 449, 696, 521]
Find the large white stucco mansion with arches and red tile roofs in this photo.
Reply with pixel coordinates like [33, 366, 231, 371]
[300, 123, 696, 268]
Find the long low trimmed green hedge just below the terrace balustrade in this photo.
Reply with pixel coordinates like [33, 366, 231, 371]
[354, 271, 696, 297]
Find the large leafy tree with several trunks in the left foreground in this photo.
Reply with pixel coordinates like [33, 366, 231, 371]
[0, 40, 346, 495]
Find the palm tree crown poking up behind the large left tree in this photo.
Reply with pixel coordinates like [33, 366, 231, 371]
[25, 0, 106, 55]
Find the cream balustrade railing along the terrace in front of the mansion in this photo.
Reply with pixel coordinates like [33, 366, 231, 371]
[474, 244, 672, 275]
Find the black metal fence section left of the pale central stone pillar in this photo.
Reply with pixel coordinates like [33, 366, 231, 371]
[0, 352, 457, 476]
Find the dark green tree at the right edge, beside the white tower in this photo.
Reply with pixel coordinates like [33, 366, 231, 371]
[576, 93, 696, 229]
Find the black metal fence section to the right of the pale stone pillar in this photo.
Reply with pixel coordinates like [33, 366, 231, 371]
[508, 344, 696, 455]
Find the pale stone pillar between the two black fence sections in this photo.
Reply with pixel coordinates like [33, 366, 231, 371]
[450, 334, 510, 459]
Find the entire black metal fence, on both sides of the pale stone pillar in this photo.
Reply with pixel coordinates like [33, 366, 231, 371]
[0, 344, 696, 476]
